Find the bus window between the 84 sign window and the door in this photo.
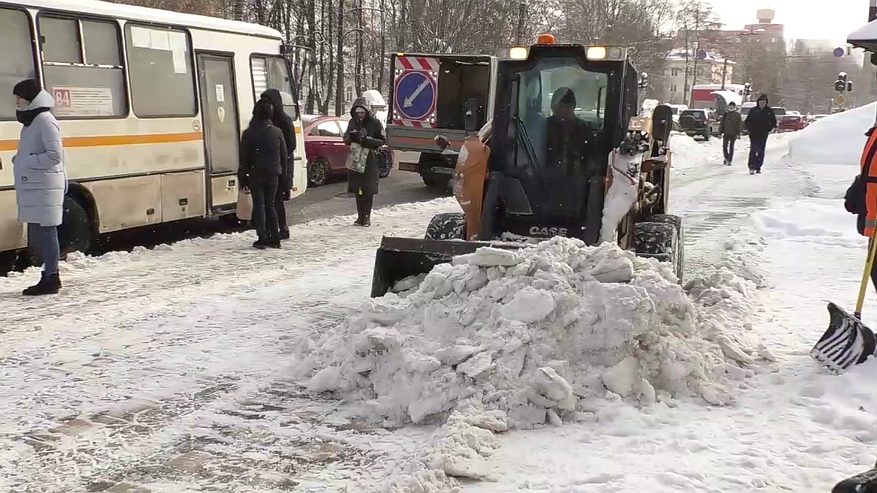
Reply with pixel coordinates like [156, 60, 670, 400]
[125, 23, 198, 118]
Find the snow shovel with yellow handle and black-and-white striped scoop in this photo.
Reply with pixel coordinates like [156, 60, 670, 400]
[810, 234, 877, 373]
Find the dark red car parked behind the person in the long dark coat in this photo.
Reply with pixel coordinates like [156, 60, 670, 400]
[302, 115, 393, 187]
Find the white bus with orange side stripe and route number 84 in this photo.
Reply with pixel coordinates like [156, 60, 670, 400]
[0, 0, 307, 264]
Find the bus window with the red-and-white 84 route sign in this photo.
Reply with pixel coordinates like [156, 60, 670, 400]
[39, 15, 128, 119]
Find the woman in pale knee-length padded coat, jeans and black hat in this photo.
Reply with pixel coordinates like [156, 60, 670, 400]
[12, 79, 67, 296]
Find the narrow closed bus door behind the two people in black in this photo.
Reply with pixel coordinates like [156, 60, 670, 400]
[198, 53, 241, 213]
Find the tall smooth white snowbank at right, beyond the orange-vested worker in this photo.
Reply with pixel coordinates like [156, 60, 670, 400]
[789, 103, 877, 165]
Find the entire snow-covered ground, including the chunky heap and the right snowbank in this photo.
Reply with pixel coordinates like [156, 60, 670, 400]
[0, 113, 877, 493]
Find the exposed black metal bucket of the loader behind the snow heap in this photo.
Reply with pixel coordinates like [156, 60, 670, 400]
[371, 236, 519, 298]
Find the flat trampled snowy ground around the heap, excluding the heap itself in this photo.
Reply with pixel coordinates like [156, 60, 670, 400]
[0, 128, 877, 493]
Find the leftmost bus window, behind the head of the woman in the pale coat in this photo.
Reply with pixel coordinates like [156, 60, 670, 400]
[0, 7, 35, 120]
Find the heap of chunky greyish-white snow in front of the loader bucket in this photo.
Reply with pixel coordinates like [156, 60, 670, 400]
[297, 238, 742, 428]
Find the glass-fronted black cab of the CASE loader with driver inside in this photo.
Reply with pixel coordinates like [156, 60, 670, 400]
[479, 44, 638, 244]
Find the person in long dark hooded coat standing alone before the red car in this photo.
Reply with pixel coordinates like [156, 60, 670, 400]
[344, 98, 387, 227]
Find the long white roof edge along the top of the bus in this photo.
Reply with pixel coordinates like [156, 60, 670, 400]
[16, 0, 282, 39]
